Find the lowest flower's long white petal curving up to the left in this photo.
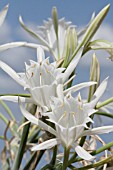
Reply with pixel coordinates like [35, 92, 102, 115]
[19, 98, 57, 136]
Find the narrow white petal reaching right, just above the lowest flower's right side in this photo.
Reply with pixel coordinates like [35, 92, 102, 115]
[64, 82, 96, 94]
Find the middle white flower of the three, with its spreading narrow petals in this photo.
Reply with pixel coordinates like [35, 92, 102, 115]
[0, 47, 95, 110]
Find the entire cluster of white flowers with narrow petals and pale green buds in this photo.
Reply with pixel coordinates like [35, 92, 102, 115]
[0, 2, 113, 170]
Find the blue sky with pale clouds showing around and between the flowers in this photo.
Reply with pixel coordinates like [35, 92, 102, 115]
[0, 0, 113, 168]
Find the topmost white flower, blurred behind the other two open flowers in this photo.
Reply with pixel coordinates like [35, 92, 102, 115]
[19, 7, 95, 61]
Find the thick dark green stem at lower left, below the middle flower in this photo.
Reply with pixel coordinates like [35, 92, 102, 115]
[12, 119, 30, 170]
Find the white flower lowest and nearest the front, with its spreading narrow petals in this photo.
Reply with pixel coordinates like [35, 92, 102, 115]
[20, 79, 113, 160]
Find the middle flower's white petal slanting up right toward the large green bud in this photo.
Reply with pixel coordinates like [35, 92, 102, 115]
[63, 50, 82, 82]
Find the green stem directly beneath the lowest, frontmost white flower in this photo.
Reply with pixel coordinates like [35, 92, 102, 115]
[62, 147, 70, 170]
